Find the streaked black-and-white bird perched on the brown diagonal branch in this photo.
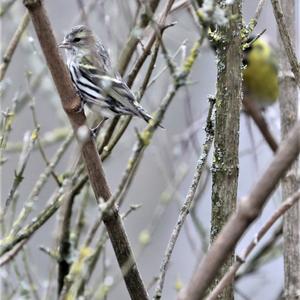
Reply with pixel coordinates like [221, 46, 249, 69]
[58, 25, 157, 130]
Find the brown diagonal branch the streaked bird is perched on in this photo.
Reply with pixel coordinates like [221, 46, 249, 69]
[23, 0, 148, 299]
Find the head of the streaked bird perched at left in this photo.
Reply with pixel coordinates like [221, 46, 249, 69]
[58, 25, 96, 53]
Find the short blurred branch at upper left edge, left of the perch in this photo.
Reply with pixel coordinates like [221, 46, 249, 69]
[0, 12, 30, 81]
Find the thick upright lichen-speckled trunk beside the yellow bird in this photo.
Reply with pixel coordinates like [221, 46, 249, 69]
[210, 1, 242, 299]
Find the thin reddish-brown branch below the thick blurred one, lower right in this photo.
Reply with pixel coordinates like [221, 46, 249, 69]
[206, 190, 300, 300]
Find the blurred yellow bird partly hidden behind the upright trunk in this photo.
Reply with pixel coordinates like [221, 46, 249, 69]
[243, 37, 279, 109]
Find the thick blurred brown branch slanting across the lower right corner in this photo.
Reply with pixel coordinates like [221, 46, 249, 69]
[179, 121, 300, 300]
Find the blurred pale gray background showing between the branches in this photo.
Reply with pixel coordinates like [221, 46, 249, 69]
[1, 0, 299, 299]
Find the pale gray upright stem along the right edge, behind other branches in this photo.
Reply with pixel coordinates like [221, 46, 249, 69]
[279, 0, 300, 299]
